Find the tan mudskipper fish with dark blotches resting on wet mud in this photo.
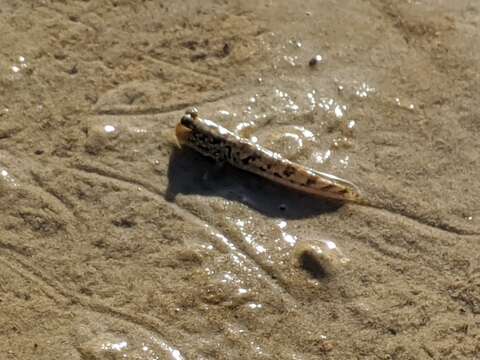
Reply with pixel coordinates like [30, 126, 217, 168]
[175, 110, 364, 203]
